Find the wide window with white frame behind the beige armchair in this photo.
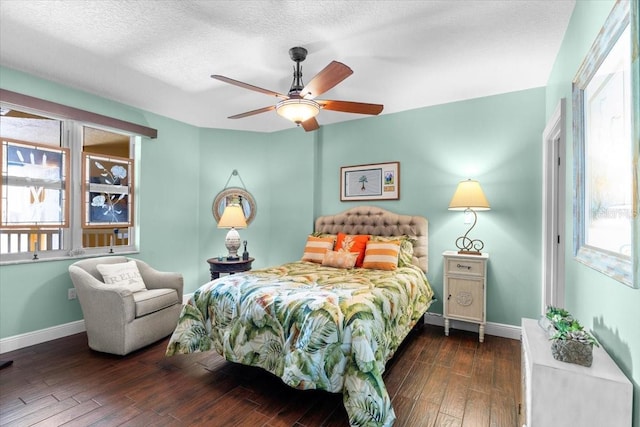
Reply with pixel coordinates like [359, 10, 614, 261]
[0, 105, 140, 263]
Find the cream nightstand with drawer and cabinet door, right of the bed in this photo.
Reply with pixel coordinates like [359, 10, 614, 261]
[442, 251, 489, 342]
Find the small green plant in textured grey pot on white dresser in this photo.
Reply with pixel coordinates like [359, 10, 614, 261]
[545, 306, 599, 367]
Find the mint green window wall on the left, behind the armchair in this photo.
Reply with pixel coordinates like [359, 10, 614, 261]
[0, 68, 206, 338]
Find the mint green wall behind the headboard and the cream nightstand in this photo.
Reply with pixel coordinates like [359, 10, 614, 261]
[318, 88, 544, 325]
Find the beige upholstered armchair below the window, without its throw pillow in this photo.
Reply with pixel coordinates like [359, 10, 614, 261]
[69, 256, 183, 355]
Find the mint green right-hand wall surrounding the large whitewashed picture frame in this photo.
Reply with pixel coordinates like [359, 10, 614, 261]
[546, 0, 640, 426]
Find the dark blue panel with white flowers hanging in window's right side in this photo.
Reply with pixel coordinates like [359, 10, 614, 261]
[82, 153, 133, 227]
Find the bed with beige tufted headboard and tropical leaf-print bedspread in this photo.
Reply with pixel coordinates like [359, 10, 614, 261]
[166, 206, 433, 426]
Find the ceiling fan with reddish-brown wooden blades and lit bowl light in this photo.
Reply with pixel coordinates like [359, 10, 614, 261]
[211, 47, 384, 132]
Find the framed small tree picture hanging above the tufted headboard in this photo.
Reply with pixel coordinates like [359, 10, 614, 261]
[340, 162, 400, 202]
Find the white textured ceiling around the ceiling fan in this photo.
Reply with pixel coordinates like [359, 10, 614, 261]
[0, 0, 575, 132]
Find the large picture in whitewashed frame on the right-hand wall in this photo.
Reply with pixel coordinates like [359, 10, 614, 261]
[572, 1, 640, 288]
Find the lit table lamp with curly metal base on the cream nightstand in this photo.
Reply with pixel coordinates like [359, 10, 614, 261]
[449, 179, 491, 255]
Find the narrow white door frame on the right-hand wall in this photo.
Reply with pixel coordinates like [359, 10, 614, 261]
[541, 98, 567, 314]
